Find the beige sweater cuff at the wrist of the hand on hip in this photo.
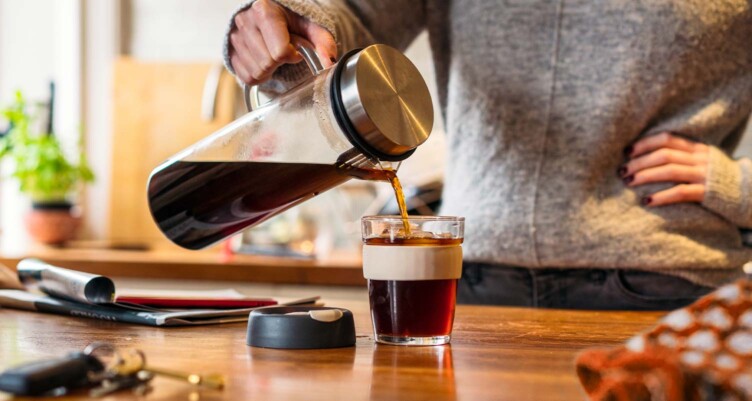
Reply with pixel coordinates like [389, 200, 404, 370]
[702, 147, 752, 229]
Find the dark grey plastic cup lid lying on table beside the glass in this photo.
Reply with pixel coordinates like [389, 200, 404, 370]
[246, 306, 355, 349]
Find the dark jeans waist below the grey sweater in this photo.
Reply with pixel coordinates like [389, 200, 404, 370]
[457, 262, 713, 310]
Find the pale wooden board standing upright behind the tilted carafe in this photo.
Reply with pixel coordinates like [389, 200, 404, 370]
[109, 58, 240, 246]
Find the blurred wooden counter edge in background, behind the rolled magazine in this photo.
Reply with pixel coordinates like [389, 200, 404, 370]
[0, 246, 366, 286]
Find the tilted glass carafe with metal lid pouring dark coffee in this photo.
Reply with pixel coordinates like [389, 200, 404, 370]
[148, 38, 433, 249]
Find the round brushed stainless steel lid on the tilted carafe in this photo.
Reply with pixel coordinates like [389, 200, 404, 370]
[335, 45, 433, 157]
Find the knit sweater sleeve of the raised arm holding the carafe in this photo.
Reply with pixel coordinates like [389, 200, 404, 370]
[223, 0, 425, 89]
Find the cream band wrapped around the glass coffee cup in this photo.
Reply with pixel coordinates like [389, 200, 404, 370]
[363, 245, 462, 281]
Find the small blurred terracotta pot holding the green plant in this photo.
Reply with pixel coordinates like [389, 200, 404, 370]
[26, 202, 81, 245]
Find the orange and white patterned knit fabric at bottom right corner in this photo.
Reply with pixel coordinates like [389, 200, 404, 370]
[576, 279, 752, 401]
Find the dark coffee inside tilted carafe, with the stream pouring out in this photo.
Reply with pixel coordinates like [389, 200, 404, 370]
[148, 161, 409, 249]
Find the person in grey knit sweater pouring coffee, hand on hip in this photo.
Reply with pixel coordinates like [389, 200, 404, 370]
[225, 0, 752, 309]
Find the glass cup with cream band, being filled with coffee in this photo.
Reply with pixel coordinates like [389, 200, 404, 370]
[362, 216, 464, 345]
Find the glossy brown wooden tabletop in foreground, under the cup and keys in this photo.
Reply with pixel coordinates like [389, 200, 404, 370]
[0, 301, 661, 401]
